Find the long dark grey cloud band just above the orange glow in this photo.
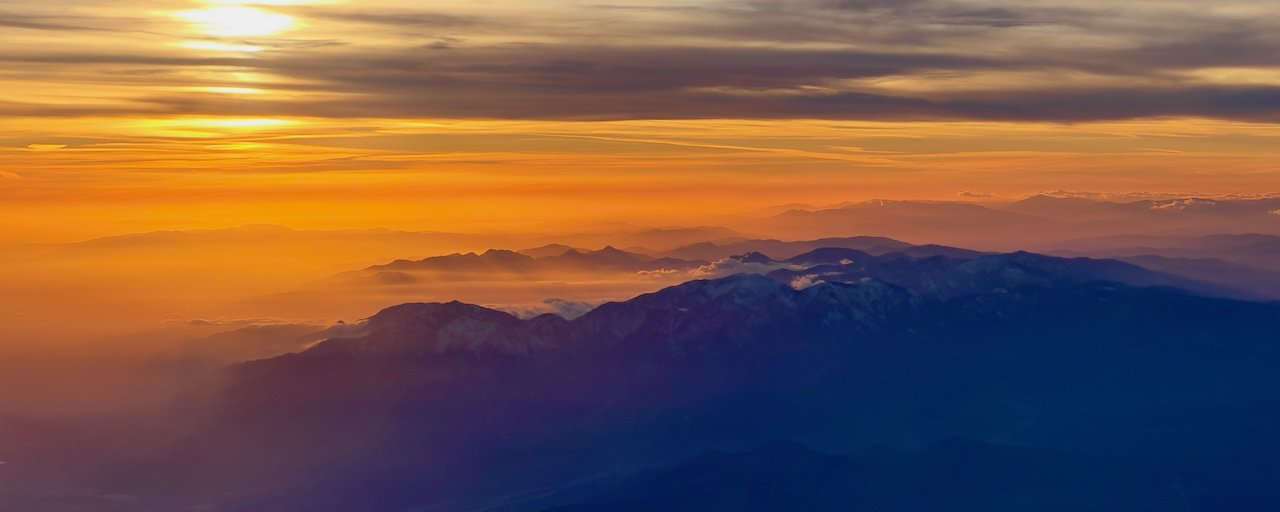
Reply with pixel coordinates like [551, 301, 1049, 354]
[0, 46, 1280, 122]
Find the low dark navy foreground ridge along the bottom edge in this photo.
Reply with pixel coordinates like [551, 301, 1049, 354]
[547, 439, 1192, 512]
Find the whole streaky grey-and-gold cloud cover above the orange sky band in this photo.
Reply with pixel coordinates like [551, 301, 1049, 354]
[0, 0, 1280, 123]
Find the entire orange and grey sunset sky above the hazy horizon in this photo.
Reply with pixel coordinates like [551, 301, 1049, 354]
[0, 0, 1280, 243]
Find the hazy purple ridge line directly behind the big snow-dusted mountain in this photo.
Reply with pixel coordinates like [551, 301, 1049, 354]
[335, 236, 1280, 304]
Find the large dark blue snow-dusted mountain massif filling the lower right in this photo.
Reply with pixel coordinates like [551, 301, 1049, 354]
[97, 252, 1280, 511]
